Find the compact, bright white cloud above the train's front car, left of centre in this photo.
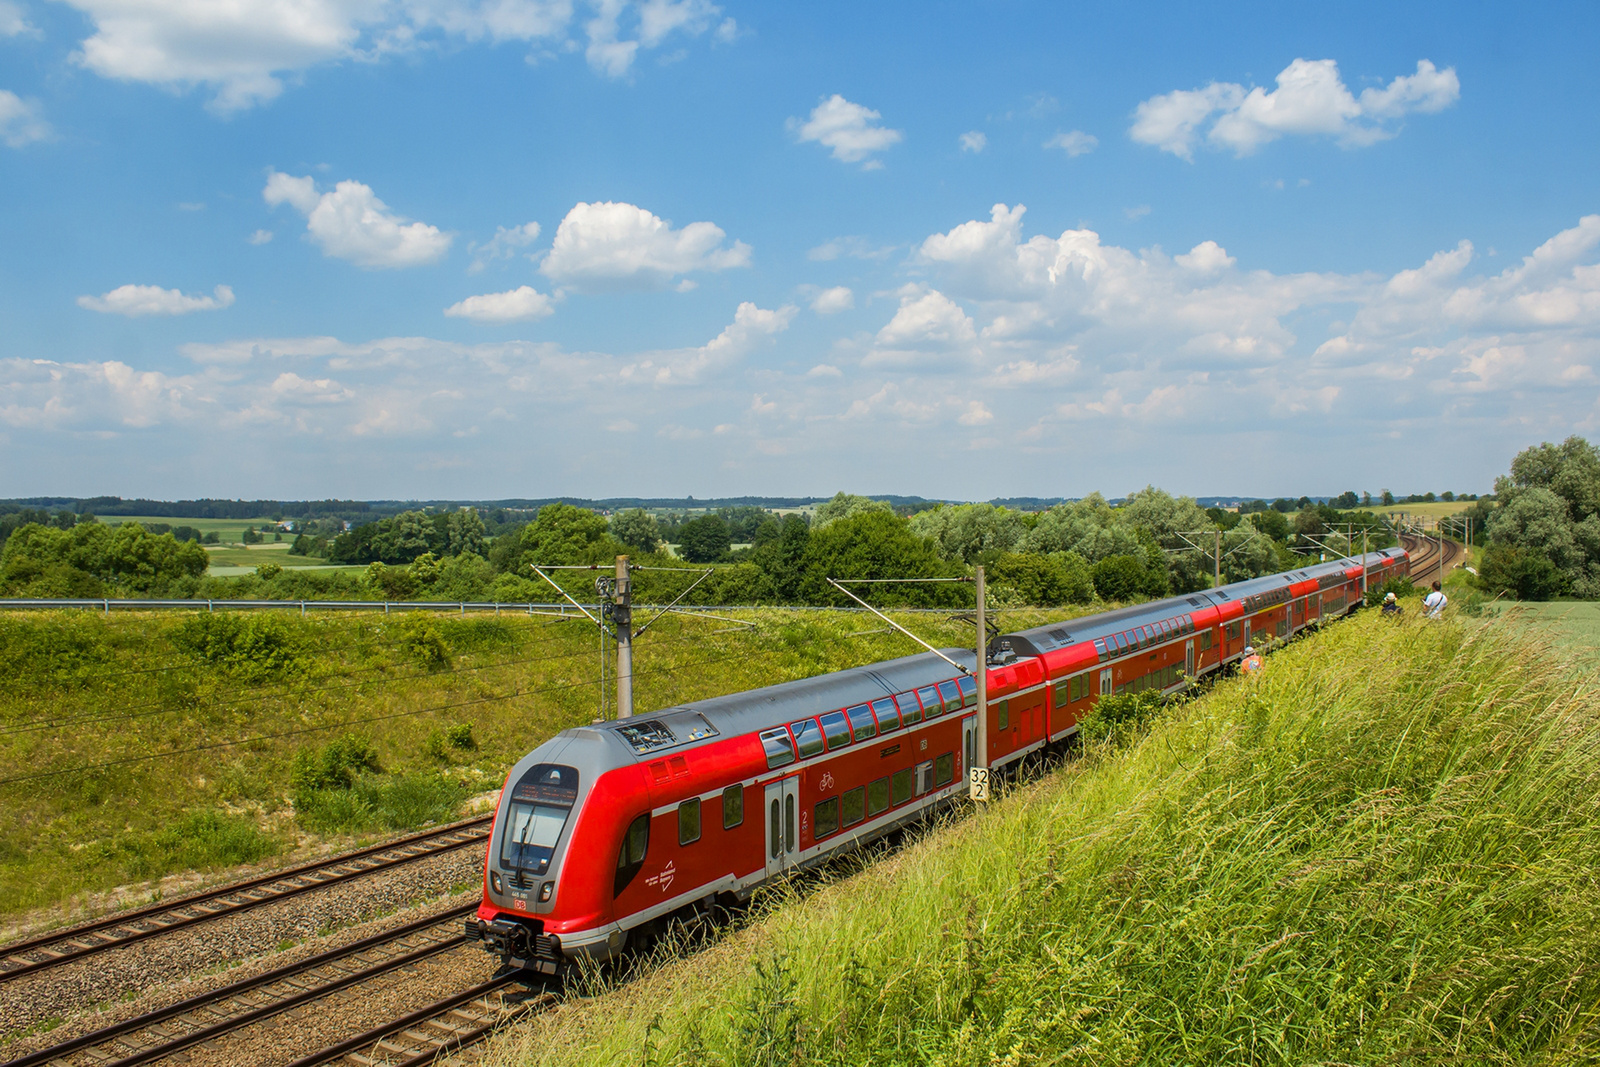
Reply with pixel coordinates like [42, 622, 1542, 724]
[539, 202, 750, 290]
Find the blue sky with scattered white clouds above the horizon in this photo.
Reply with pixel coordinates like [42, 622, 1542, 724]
[0, 0, 1600, 499]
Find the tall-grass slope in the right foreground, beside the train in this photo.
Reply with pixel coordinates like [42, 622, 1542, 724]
[494, 613, 1600, 1067]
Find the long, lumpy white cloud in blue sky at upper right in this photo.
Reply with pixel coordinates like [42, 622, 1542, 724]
[1128, 59, 1461, 160]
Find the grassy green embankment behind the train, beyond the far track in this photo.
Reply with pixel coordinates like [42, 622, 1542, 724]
[0, 611, 1066, 915]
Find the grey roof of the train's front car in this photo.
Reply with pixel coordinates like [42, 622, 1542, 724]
[571, 648, 978, 760]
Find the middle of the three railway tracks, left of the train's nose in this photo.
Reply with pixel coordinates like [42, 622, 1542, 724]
[0, 904, 477, 1067]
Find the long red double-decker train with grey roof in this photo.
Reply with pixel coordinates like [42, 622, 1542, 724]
[467, 549, 1408, 974]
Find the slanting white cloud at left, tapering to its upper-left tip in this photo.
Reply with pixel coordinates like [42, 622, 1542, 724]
[261, 171, 453, 269]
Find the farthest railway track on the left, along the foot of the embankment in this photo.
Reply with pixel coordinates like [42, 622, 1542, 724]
[0, 816, 493, 982]
